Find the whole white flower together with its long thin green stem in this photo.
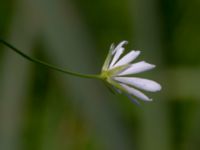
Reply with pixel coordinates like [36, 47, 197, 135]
[0, 40, 161, 104]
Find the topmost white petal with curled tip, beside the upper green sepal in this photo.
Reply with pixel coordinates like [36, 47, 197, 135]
[109, 41, 128, 69]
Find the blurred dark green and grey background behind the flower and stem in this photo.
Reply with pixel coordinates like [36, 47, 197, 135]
[0, 0, 200, 150]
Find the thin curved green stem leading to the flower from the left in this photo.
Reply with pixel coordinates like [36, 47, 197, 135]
[0, 39, 100, 79]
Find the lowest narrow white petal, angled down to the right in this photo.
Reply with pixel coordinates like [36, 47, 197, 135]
[120, 84, 152, 101]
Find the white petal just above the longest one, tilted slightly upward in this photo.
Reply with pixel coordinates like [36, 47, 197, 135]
[119, 61, 155, 76]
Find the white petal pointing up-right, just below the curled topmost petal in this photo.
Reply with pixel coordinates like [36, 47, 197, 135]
[113, 50, 140, 67]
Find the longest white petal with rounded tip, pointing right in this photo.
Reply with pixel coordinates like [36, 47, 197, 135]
[114, 77, 161, 92]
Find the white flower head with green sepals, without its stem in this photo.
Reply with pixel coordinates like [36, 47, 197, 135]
[101, 41, 161, 102]
